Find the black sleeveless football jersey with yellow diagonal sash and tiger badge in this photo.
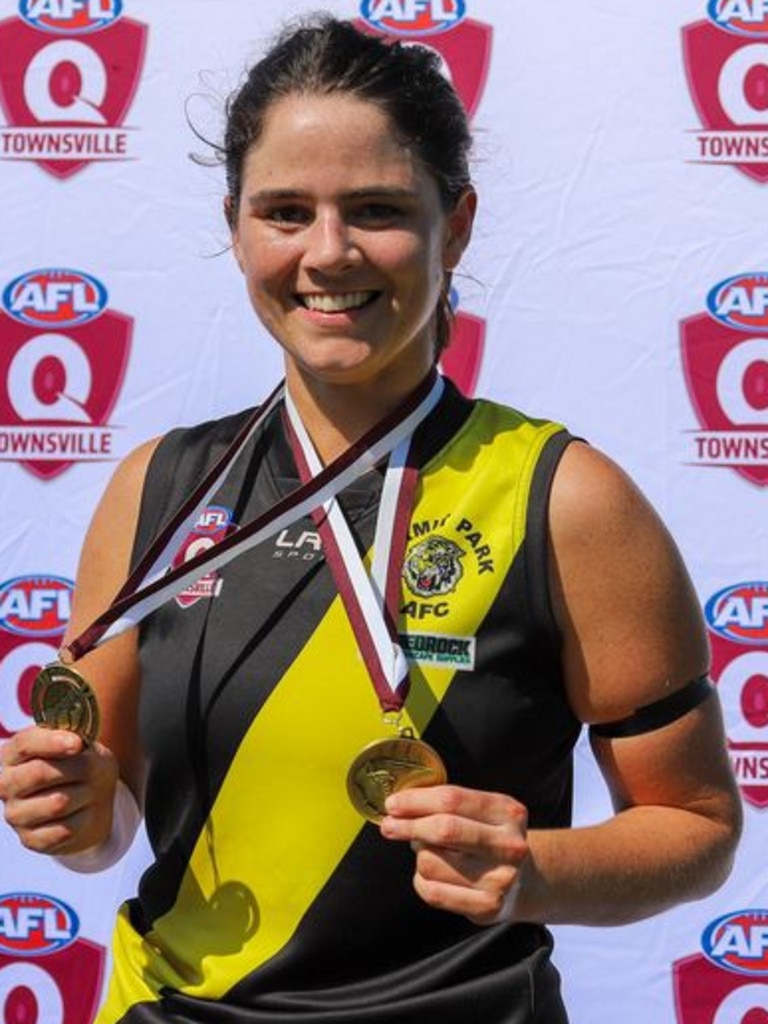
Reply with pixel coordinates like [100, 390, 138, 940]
[98, 385, 580, 1024]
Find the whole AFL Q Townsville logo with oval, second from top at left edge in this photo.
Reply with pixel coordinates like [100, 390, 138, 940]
[0, 268, 133, 479]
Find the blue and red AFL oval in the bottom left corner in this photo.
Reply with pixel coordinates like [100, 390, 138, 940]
[0, 893, 80, 956]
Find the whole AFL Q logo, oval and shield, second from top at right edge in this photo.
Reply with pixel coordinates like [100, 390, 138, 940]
[680, 273, 768, 486]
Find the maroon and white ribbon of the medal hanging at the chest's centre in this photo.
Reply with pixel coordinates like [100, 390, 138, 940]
[286, 378, 443, 713]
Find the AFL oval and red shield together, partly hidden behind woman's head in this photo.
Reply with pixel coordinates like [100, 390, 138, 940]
[356, 0, 493, 118]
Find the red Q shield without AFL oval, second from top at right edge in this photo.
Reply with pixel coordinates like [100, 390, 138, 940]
[681, 313, 768, 486]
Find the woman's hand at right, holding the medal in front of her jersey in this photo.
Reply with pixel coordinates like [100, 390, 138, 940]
[380, 785, 528, 925]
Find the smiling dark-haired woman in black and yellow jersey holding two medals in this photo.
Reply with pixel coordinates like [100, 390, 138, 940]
[0, 18, 739, 1024]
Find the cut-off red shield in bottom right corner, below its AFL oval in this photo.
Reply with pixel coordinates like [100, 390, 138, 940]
[673, 953, 768, 1024]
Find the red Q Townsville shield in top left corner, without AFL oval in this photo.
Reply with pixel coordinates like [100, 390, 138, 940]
[0, 17, 147, 178]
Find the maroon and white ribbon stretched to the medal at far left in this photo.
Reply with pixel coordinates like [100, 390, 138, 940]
[63, 372, 442, 660]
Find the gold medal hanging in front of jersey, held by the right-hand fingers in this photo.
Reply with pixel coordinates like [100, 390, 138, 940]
[347, 732, 447, 822]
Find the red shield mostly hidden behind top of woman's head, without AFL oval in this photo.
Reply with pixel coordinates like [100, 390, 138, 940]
[354, 18, 494, 118]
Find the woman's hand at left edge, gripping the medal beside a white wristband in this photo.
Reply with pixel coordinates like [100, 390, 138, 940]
[0, 726, 118, 854]
